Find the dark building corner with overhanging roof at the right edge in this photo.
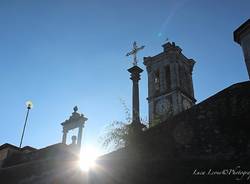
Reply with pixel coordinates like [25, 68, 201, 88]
[234, 19, 250, 79]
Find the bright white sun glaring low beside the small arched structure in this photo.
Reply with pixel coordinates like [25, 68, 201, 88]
[79, 147, 100, 171]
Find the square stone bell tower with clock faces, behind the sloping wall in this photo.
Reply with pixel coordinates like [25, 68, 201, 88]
[144, 42, 196, 127]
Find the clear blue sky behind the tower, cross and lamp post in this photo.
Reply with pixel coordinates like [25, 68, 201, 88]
[0, 0, 250, 152]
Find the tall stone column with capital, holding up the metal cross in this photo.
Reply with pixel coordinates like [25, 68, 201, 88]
[128, 66, 144, 130]
